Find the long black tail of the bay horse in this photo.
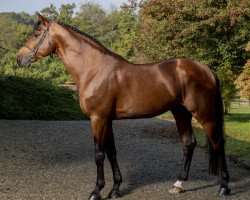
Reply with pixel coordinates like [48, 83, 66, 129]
[207, 74, 225, 175]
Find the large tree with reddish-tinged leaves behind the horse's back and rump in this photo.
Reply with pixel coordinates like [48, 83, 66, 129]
[136, 0, 250, 111]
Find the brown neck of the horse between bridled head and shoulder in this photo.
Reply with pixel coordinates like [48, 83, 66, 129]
[54, 25, 111, 84]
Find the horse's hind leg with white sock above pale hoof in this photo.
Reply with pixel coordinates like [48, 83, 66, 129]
[170, 105, 196, 193]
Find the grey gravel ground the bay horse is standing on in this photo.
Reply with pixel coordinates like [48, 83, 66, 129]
[0, 119, 250, 200]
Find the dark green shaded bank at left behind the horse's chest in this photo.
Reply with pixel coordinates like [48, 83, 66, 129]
[0, 75, 86, 120]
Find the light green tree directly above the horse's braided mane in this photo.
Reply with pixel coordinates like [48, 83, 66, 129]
[73, 0, 138, 60]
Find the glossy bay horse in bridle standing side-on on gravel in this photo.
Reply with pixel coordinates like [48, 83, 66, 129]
[17, 13, 230, 200]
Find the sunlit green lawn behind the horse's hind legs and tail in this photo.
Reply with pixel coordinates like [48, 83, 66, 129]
[160, 103, 250, 160]
